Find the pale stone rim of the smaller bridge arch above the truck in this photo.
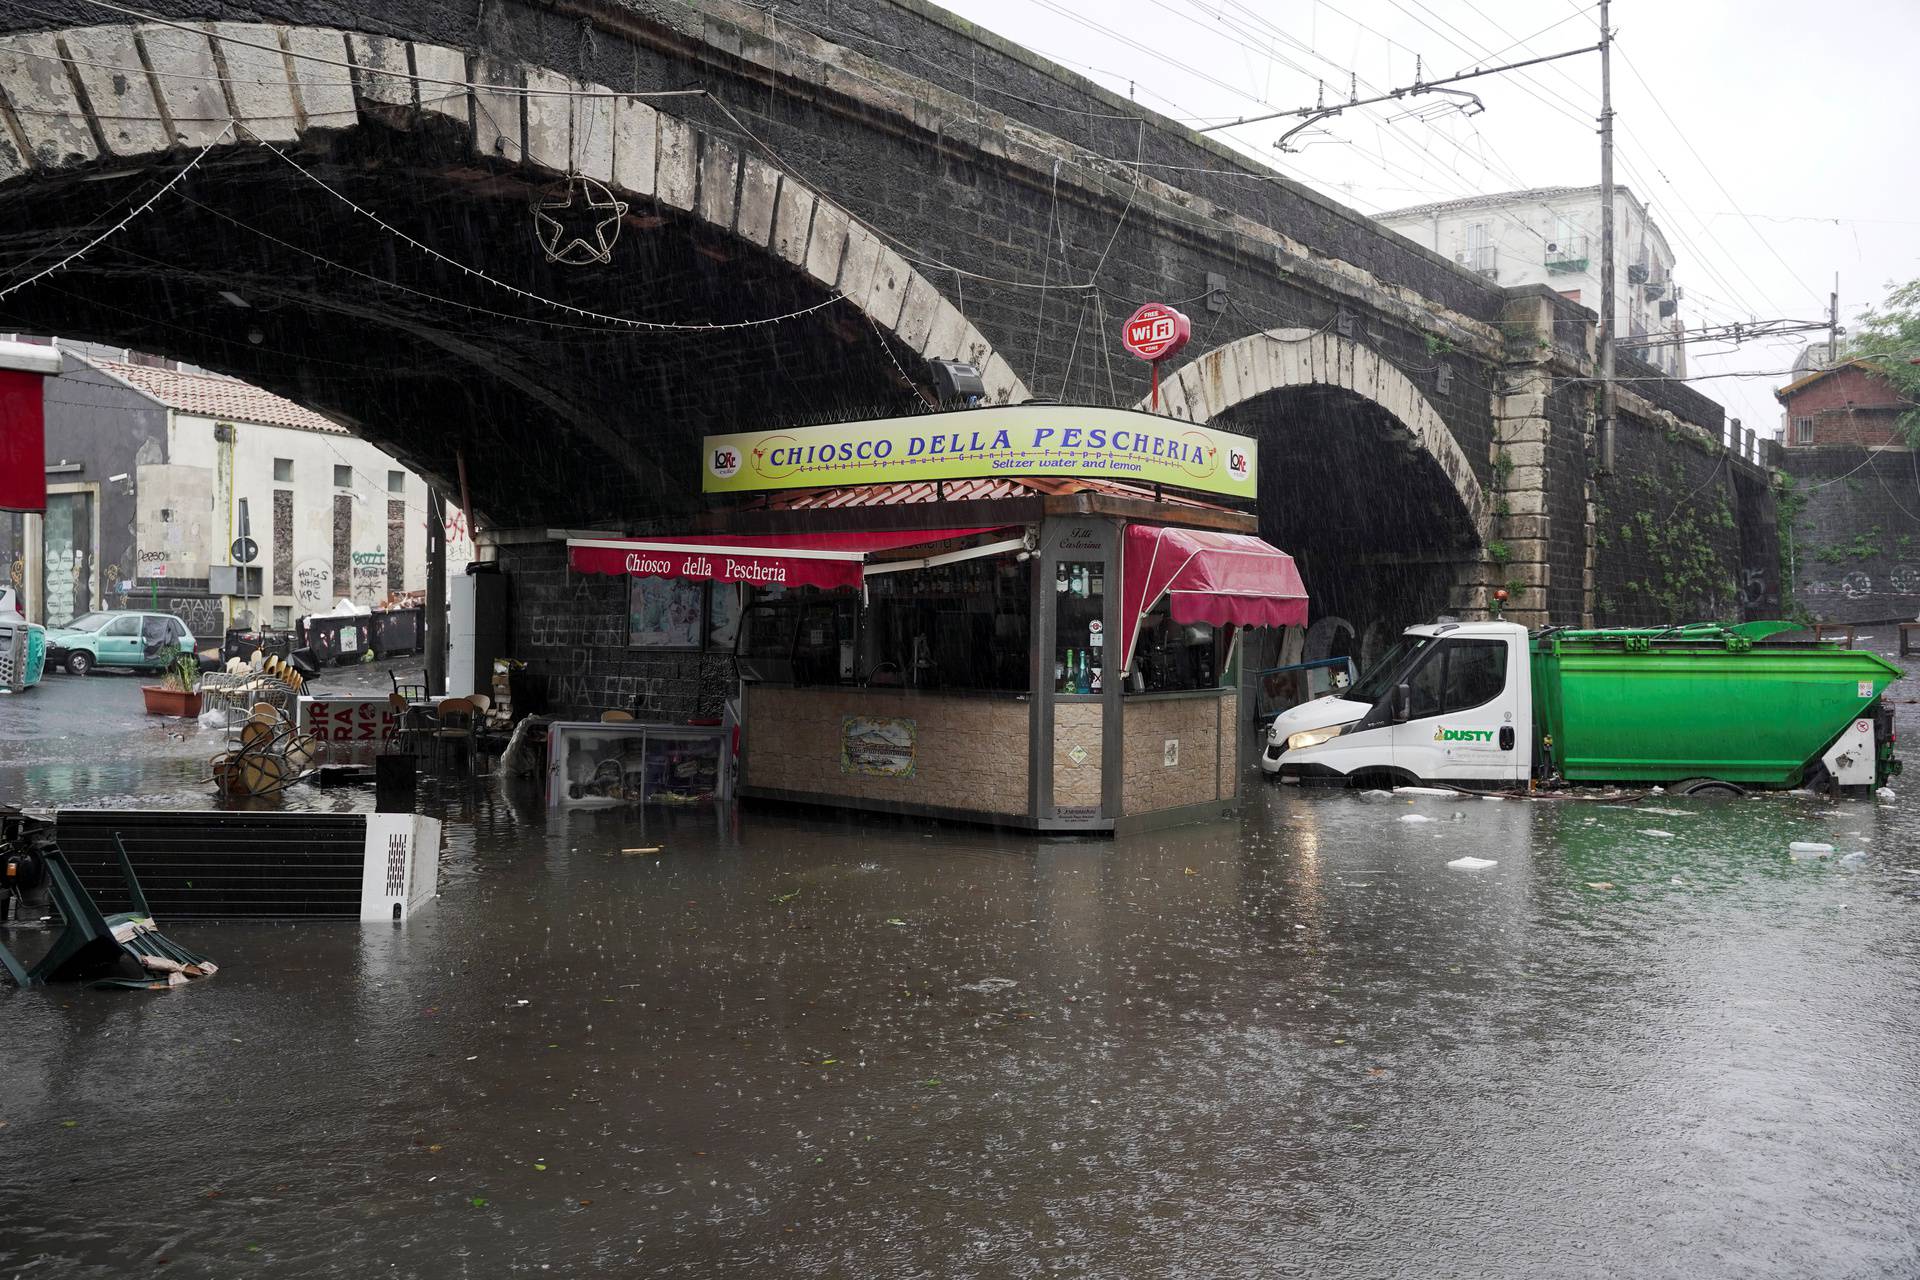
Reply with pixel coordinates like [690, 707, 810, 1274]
[1135, 328, 1488, 539]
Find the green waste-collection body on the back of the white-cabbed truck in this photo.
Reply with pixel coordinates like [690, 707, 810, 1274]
[1532, 622, 1901, 787]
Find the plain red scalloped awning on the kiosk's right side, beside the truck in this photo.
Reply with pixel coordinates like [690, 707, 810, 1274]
[1119, 524, 1308, 670]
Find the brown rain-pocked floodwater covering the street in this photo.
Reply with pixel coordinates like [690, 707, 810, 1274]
[0, 656, 1920, 1278]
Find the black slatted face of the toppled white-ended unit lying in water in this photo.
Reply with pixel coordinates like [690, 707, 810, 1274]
[54, 810, 367, 921]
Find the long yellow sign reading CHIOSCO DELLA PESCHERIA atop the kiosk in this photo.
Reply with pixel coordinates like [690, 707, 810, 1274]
[701, 405, 1256, 501]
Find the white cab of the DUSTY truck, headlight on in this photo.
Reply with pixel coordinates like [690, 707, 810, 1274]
[1260, 622, 1534, 785]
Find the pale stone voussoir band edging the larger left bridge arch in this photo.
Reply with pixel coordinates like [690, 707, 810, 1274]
[0, 21, 1027, 403]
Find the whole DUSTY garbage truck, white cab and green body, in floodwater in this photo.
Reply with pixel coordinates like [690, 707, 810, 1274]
[1260, 620, 1901, 793]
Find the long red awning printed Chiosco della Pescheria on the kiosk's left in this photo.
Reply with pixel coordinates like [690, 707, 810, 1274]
[566, 528, 991, 591]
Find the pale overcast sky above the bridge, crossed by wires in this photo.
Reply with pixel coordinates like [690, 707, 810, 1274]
[945, 0, 1920, 432]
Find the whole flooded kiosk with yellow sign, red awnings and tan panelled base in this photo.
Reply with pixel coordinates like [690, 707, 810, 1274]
[568, 405, 1308, 831]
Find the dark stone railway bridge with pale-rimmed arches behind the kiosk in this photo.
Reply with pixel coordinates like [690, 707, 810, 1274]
[0, 0, 1770, 626]
